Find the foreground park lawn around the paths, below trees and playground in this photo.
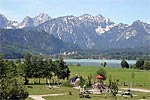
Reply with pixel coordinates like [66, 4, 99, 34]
[26, 85, 150, 100]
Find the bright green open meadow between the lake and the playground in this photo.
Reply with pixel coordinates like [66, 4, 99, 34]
[69, 66, 150, 89]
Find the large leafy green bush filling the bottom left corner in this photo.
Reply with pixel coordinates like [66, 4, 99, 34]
[0, 76, 28, 100]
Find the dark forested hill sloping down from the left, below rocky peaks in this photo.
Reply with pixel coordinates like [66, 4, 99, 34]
[0, 29, 77, 57]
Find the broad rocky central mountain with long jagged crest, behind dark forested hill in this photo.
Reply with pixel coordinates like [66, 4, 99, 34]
[36, 14, 114, 49]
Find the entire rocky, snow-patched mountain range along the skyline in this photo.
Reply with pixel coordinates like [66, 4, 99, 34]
[0, 13, 150, 57]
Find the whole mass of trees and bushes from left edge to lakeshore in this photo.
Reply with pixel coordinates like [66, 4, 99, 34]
[0, 52, 70, 100]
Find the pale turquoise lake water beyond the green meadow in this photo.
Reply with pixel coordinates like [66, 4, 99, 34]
[64, 59, 136, 68]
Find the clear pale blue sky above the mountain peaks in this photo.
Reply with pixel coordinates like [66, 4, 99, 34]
[0, 0, 150, 24]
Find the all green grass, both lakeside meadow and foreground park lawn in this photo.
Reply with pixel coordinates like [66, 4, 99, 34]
[27, 66, 150, 100]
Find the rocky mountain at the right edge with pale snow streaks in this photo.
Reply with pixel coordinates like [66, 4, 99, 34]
[102, 20, 150, 48]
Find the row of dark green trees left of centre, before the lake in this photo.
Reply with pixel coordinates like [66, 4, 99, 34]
[23, 52, 70, 83]
